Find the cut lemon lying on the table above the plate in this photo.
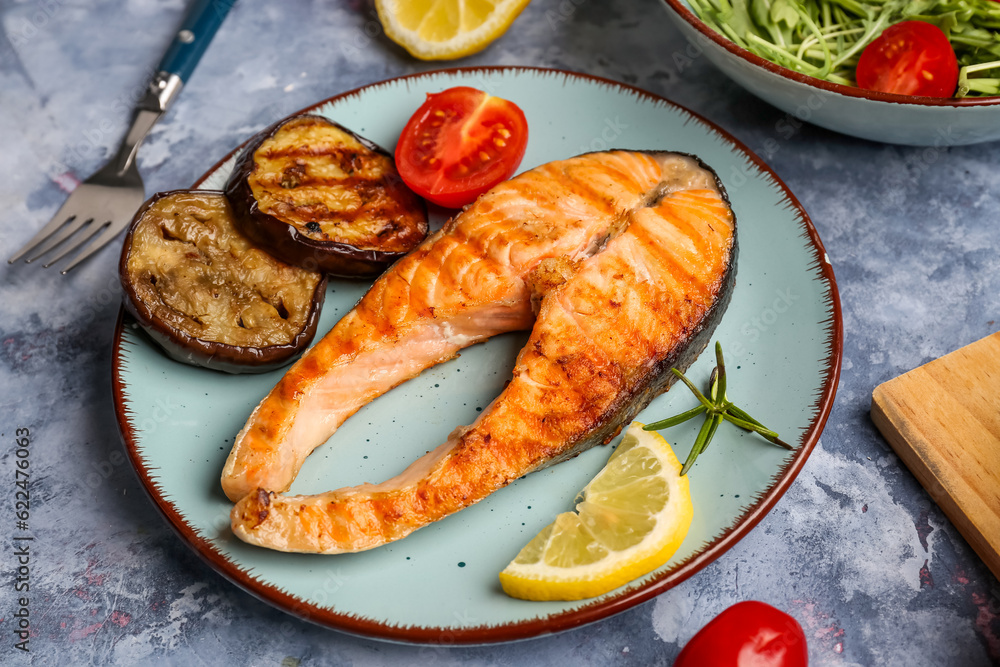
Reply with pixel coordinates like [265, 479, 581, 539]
[375, 0, 529, 60]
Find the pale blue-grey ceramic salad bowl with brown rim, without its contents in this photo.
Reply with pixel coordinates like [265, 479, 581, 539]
[664, 0, 1000, 146]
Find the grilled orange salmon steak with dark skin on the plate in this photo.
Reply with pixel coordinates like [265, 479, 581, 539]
[230, 151, 738, 554]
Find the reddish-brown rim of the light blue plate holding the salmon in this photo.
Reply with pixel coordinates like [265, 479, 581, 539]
[112, 66, 843, 645]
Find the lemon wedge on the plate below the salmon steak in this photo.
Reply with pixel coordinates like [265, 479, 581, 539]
[500, 422, 694, 600]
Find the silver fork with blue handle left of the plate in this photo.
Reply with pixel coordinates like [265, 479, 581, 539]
[7, 0, 235, 274]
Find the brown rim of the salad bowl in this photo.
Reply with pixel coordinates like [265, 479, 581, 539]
[663, 0, 1000, 108]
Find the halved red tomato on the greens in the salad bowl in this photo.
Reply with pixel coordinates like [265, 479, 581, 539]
[857, 21, 958, 97]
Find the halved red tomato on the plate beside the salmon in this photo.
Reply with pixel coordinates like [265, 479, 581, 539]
[396, 86, 528, 208]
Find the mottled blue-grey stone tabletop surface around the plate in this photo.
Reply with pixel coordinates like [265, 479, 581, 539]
[0, 0, 1000, 667]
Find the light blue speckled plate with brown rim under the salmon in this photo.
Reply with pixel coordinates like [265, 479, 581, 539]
[114, 68, 842, 643]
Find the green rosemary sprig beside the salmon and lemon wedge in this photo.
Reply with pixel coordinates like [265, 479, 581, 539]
[642, 341, 793, 475]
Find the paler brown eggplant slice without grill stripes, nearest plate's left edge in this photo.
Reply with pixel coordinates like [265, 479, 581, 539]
[118, 190, 326, 373]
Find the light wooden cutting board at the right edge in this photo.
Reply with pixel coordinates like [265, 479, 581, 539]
[871, 332, 1000, 578]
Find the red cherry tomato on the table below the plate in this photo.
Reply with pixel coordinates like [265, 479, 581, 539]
[674, 600, 809, 667]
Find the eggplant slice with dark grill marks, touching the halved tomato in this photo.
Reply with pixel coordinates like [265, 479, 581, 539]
[225, 114, 429, 278]
